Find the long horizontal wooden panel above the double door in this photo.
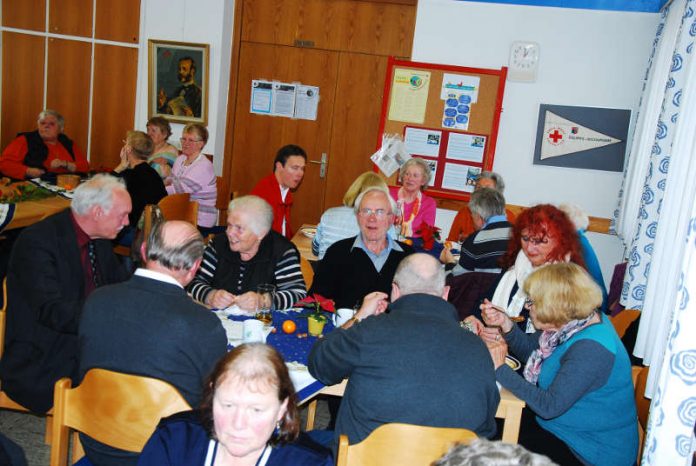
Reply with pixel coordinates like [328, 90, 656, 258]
[242, 0, 416, 57]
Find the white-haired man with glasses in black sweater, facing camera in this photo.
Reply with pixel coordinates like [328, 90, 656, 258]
[309, 188, 413, 308]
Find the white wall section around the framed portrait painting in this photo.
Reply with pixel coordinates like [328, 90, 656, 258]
[135, 0, 234, 175]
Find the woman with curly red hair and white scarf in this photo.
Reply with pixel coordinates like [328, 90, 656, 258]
[466, 204, 585, 341]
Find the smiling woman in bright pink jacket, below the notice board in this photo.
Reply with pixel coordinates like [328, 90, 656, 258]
[389, 157, 437, 237]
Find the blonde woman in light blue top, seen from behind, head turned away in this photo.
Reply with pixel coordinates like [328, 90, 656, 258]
[312, 172, 392, 260]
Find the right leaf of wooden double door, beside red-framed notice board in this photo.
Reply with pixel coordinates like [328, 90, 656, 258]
[324, 53, 387, 208]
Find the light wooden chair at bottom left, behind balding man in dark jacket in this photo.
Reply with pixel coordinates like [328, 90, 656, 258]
[50, 369, 191, 466]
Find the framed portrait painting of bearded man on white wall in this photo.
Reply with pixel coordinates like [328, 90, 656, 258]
[148, 40, 210, 124]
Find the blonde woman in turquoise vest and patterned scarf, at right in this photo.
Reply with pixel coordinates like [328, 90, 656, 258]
[482, 263, 638, 466]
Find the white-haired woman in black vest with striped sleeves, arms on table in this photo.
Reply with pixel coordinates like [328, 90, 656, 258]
[188, 196, 307, 313]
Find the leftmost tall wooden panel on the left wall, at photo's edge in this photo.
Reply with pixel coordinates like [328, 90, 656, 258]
[0, 32, 45, 148]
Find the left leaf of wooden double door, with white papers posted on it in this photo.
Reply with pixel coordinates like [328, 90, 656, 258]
[231, 42, 338, 229]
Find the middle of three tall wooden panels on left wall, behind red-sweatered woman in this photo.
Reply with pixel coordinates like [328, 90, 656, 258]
[46, 38, 92, 155]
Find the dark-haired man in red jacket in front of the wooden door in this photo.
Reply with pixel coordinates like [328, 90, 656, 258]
[251, 144, 307, 238]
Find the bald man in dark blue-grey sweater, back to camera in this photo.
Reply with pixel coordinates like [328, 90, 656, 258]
[309, 254, 500, 444]
